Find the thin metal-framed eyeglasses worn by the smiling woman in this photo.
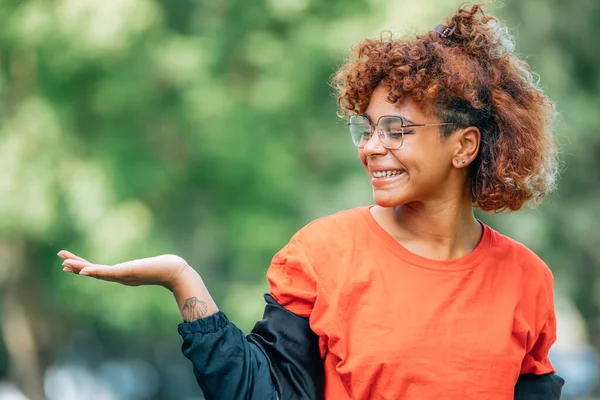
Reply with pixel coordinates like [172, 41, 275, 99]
[346, 115, 456, 150]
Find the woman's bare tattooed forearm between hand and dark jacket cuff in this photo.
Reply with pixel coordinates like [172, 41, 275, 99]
[170, 266, 219, 322]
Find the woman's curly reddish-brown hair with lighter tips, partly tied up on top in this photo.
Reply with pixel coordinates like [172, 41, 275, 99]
[333, 5, 556, 211]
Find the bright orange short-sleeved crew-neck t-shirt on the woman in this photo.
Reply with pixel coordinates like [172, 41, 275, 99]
[267, 207, 556, 400]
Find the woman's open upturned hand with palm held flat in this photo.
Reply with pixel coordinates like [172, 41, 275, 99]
[58, 250, 191, 290]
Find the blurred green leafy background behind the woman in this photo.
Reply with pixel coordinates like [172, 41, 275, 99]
[0, 0, 600, 400]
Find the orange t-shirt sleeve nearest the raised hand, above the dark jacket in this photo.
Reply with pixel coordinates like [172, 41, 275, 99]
[267, 234, 317, 318]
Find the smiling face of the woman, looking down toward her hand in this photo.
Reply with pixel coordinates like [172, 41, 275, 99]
[358, 86, 457, 207]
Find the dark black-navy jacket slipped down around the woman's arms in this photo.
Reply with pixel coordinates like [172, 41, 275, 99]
[178, 294, 564, 400]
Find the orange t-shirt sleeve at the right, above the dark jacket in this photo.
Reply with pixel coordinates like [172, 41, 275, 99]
[521, 308, 556, 375]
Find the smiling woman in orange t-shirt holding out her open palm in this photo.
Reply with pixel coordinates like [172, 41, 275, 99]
[59, 6, 563, 400]
